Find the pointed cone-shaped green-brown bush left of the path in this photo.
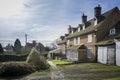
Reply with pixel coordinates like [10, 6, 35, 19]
[26, 48, 49, 70]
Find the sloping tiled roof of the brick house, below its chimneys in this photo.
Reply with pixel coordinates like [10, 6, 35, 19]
[67, 7, 118, 39]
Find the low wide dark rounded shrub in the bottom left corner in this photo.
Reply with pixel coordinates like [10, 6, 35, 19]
[0, 62, 35, 76]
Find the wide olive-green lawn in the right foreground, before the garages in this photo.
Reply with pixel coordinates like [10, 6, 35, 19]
[59, 63, 120, 80]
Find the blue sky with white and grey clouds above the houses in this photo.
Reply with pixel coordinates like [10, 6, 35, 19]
[0, 0, 120, 45]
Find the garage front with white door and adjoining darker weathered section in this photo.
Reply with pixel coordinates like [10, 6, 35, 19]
[97, 45, 116, 65]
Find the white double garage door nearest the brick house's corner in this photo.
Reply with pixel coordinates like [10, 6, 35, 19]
[98, 47, 107, 64]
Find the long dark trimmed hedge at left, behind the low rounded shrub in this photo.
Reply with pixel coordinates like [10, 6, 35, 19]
[0, 54, 28, 62]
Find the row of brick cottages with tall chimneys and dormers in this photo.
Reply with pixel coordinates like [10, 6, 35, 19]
[58, 5, 120, 64]
